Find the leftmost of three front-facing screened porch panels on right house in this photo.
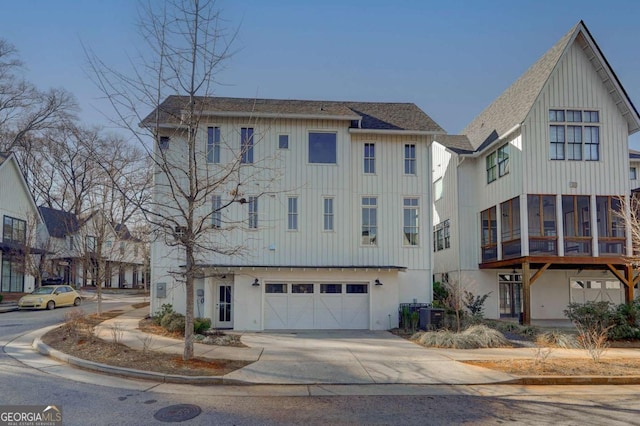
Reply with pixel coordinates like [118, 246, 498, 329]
[527, 195, 558, 255]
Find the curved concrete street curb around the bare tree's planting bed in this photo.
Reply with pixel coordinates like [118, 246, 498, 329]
[32, 337, 252, 385]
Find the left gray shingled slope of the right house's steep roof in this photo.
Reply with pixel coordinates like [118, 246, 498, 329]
[461, 22, 582, 149]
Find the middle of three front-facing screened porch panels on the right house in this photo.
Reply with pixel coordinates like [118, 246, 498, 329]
[562, 195, 591, 256]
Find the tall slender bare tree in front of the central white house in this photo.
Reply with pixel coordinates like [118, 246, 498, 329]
[82, 0, 279, 359]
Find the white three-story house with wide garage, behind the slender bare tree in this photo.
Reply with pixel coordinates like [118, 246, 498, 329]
[150, 96, 444, 330]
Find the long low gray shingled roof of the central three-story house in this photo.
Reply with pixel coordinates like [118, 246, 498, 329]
[142, 96, 445, 133]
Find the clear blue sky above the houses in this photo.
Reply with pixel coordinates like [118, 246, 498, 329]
[0, 0, 640, 149]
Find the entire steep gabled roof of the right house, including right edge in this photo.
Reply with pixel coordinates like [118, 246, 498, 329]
[462, 21, 640, 151]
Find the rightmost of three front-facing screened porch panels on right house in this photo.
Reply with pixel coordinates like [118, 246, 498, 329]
[596, 196, 625, 255]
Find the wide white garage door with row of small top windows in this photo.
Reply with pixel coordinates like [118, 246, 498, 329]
[264, 283, 369, 330]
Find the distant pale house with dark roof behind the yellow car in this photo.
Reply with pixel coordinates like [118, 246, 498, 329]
[39, 206, 145, 288]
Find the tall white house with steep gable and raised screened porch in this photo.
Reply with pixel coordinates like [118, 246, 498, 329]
[432, 22, 640, 323]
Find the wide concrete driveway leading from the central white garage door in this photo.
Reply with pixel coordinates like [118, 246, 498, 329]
[225, 331, 513, 384]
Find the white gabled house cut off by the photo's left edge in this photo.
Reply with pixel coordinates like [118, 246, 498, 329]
[0, 153, 46, 293]
